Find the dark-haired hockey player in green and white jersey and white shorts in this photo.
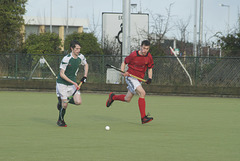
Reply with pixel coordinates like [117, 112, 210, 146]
[56, 40, 88, 127]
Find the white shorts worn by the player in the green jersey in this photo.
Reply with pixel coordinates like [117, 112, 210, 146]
[56, 83, 80, 99]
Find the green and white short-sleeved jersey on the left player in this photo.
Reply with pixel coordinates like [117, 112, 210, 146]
[57, 53, 87, 85]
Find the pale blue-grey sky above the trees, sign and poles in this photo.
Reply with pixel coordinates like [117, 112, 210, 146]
[26, 0, 240, 41]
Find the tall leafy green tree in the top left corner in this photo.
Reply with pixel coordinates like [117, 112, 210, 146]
[0, 0, 27, 53]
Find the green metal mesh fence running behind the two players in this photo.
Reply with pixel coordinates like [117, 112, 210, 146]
[0, 53, 240, 87]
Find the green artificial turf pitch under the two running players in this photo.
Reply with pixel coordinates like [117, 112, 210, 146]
[0, 91, 240, 161]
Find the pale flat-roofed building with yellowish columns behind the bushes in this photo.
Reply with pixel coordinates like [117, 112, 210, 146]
[22, 16, 89, 50]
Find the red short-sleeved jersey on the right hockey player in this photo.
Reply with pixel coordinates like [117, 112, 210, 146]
[124, 51, 154, 78]
